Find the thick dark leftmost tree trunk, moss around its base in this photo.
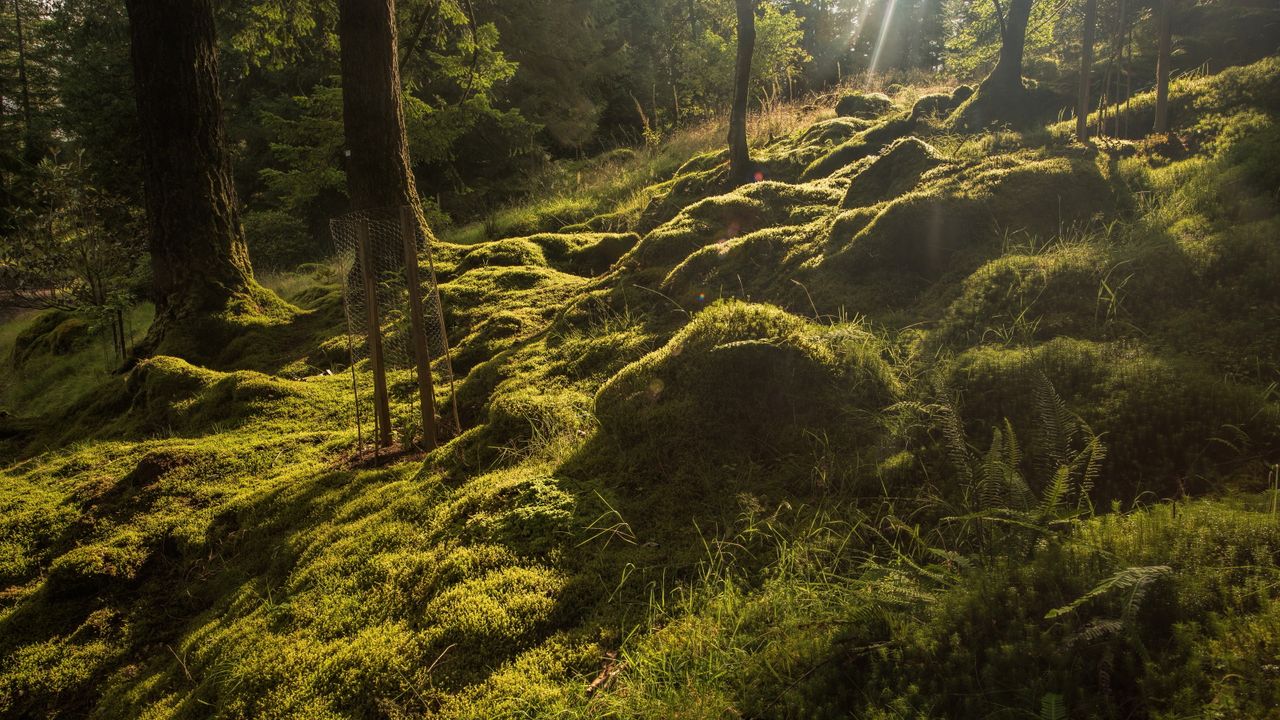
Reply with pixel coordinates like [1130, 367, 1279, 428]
[125, 0, 265, 351]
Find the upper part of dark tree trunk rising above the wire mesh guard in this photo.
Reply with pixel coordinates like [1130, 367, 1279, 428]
[338, 0, 422, 218]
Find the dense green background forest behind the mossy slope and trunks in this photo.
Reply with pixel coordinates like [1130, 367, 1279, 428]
[0, 0, 1276, 279]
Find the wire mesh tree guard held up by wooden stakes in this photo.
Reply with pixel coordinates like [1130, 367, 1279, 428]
[329, 206, 461, 454]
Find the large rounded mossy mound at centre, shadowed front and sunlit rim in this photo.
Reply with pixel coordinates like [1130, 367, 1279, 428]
[595, 302, 897, 464]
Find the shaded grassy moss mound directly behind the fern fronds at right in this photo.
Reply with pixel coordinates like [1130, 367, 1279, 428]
[947, 338, 1280, 502]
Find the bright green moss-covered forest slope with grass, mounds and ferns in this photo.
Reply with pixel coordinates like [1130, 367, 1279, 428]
[0, 59, 1280, 720]
